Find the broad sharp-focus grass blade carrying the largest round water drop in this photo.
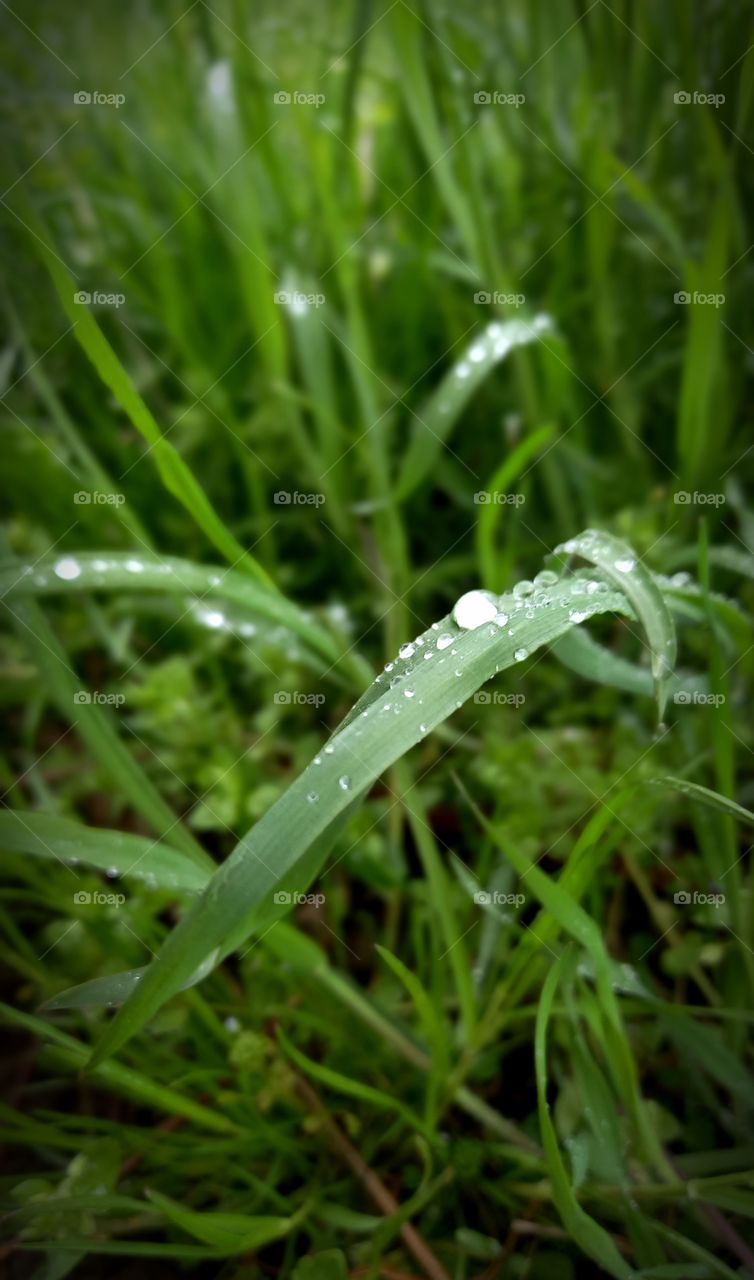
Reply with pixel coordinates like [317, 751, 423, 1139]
[88, 535, 675, 1061]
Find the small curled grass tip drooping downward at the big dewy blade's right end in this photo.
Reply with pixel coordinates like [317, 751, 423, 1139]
[554, 529, 676, 721]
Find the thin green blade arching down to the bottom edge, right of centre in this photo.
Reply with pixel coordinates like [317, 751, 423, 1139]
[534, 954, 636, 1280]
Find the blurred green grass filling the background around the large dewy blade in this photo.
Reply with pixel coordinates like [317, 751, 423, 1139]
[0, 0, 754, 1280]
